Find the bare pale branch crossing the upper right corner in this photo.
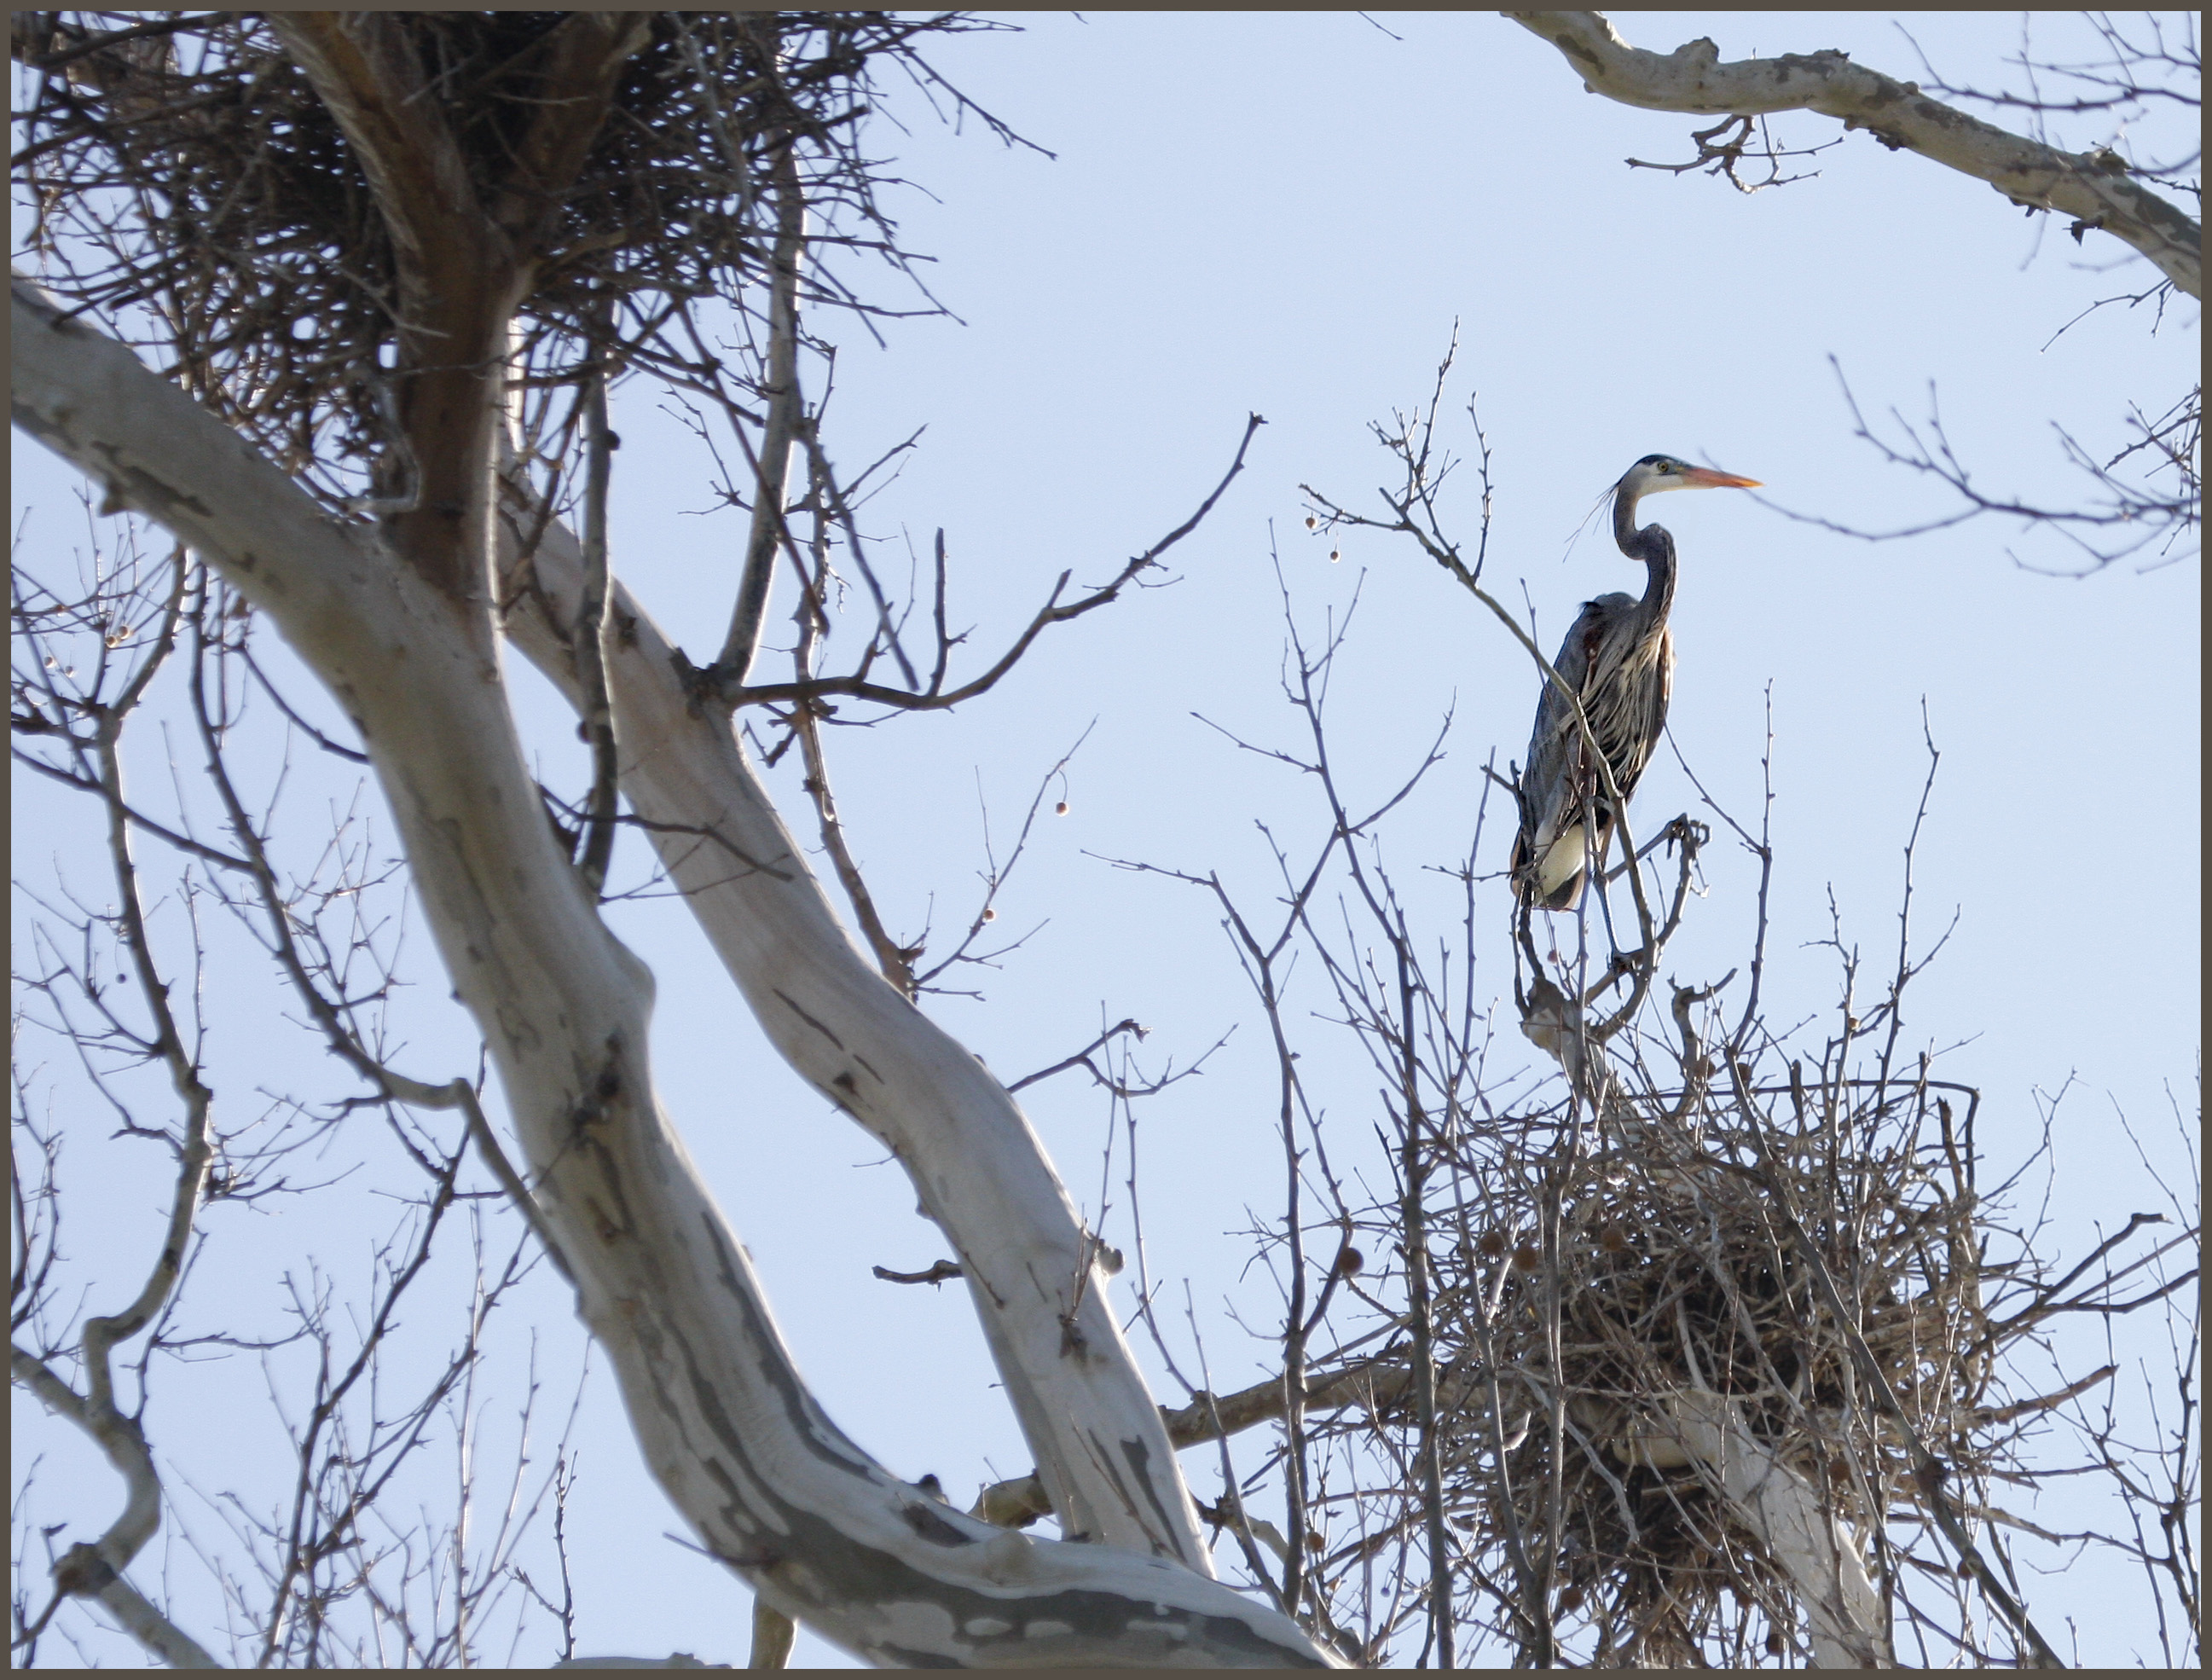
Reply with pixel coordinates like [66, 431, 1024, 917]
[1504, 11, 2203, 297]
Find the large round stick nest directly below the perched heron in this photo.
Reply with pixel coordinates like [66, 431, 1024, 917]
[1314, 1062, 2006, 1666]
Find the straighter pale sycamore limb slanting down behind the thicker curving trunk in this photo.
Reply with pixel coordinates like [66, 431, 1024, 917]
[500, 454, 1248, 1569]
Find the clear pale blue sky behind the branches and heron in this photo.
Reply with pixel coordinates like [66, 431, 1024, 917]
[15, 14, 2198, 1662]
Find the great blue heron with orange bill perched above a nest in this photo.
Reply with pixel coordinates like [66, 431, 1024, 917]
[1513, 456, 1758, 910]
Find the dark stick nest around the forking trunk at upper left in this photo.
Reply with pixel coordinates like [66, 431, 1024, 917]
[11, 11, 1004, 507]
